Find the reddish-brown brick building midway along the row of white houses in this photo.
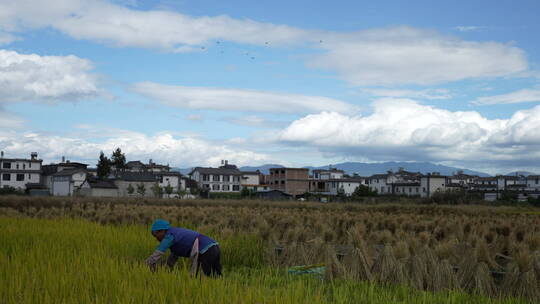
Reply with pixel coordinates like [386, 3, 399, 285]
[268, 168, 310, 195]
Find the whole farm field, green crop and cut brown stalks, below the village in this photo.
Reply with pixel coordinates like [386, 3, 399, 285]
[0, 197, 540, 303]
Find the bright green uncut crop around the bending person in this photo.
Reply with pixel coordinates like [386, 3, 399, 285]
[0, 217, 528, 304]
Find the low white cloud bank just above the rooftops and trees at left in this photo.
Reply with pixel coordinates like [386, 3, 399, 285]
[0, 131, 269, 167]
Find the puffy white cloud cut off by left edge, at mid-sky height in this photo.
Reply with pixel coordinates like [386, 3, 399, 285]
[0, 50, 100, 103]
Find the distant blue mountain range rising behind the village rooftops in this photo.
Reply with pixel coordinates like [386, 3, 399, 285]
[173, 162, 494, 177]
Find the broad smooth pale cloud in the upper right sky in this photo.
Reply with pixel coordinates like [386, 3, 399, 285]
[309, 27, 527, 86]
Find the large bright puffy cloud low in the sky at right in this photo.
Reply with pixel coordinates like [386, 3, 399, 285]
[278, 99, 540, 164]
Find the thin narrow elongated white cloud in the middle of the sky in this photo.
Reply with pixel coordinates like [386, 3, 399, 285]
[132, 82, 357, 113]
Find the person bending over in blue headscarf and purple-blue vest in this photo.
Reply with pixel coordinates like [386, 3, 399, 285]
[146, 219, 221, 276]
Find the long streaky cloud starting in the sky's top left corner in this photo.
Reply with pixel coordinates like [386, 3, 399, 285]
[0, 0, 306, 50]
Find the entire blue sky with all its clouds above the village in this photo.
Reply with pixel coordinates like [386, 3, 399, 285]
[0, 0, 540, 173]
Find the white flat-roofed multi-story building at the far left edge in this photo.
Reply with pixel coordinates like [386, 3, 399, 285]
[0, 151, 43, 190]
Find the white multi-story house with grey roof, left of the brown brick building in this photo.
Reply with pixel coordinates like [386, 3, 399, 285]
[189, 162, 242, 192]
